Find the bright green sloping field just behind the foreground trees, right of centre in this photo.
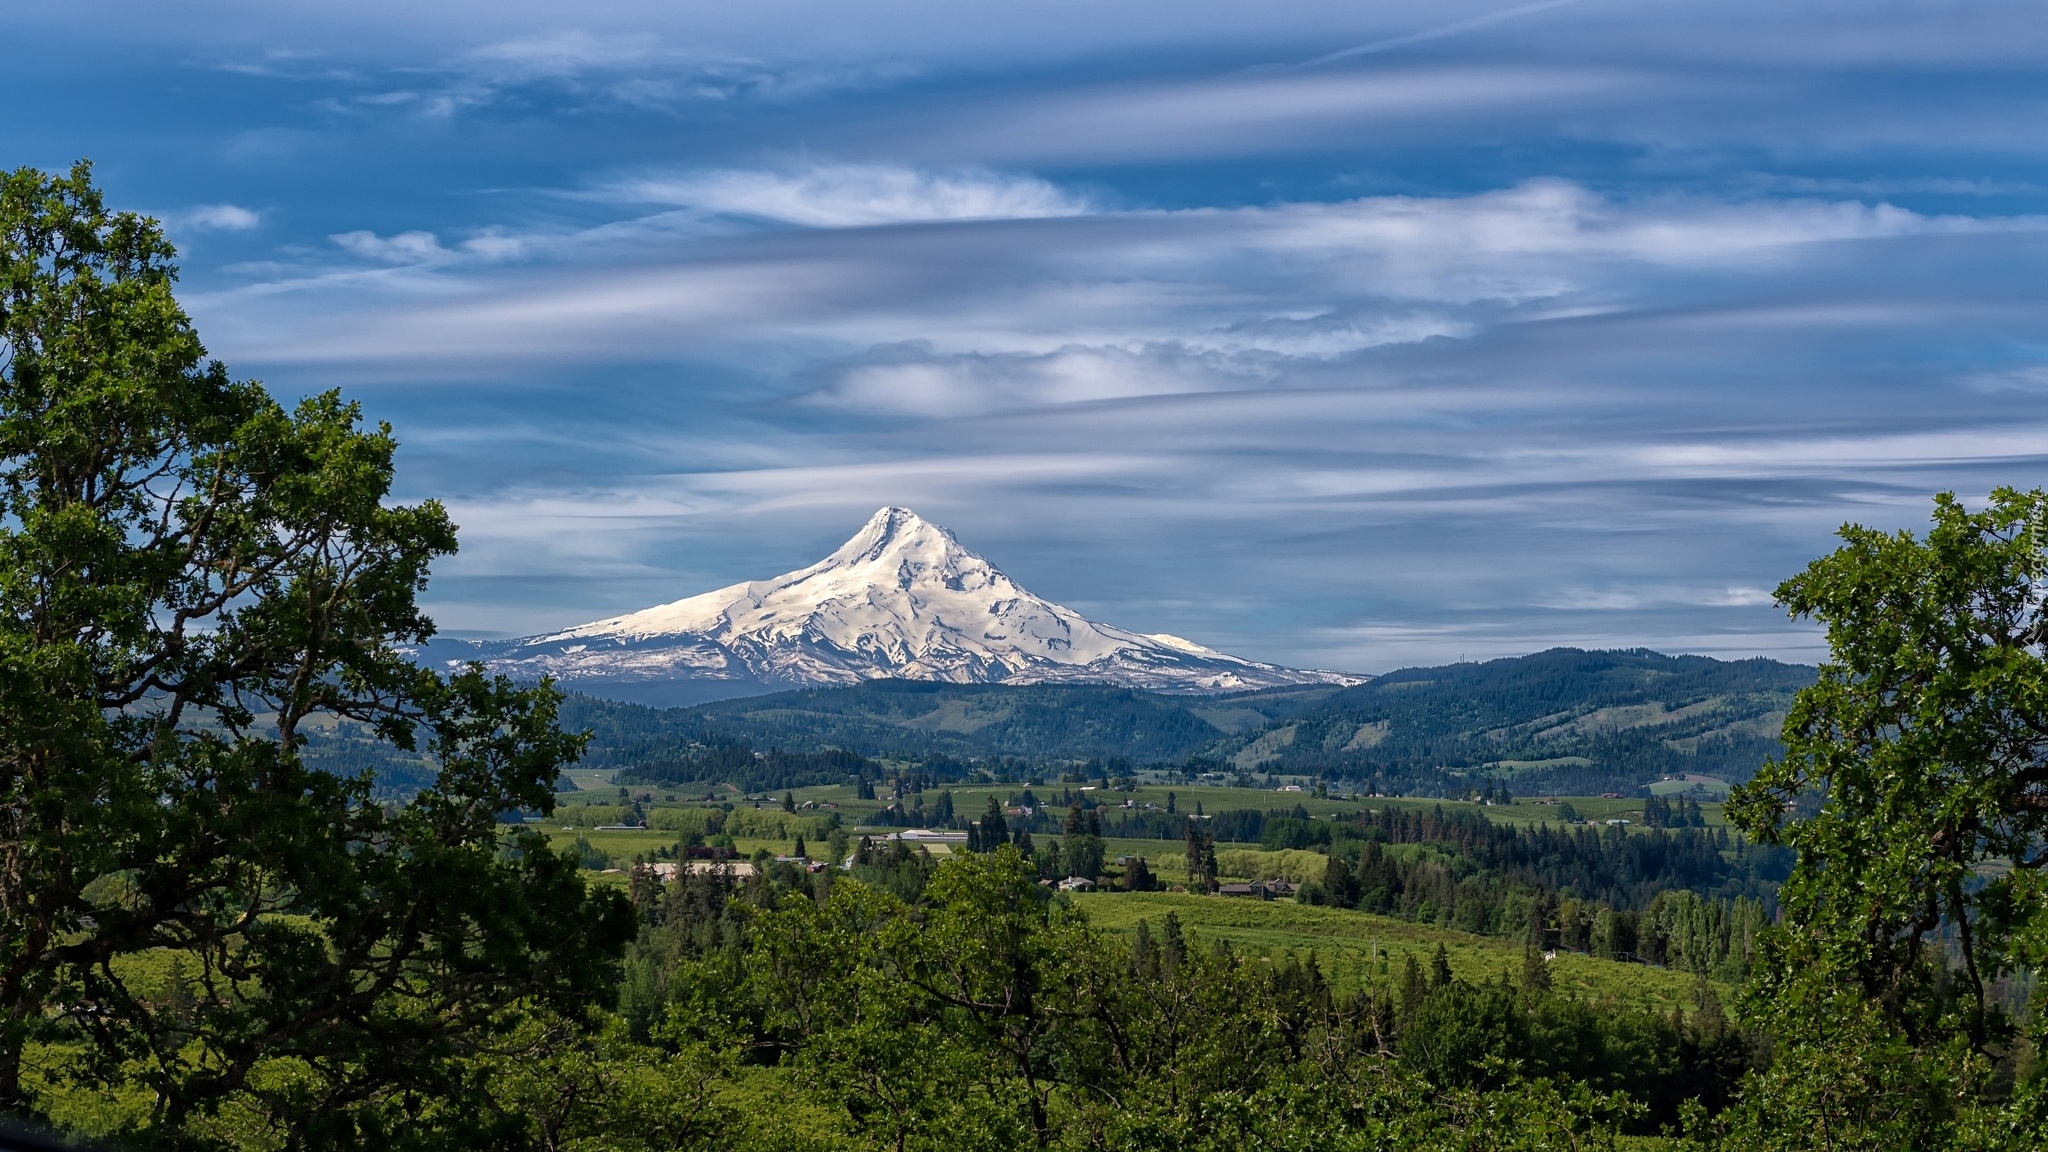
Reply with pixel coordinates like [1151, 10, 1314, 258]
[1071, 892, 1696, 1011]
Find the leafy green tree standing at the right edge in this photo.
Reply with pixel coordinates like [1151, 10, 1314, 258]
[1731, 488, 2048, 1148]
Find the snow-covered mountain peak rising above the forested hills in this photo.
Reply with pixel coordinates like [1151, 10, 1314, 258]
[426, 508, 1364, 703]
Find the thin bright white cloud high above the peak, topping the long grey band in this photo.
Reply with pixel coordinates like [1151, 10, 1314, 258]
[604, 164, 1090, 228]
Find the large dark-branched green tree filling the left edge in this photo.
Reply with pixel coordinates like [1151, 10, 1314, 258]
[0, 166, 631, 1144]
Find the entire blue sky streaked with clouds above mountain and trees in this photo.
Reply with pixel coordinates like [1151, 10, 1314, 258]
[16, 0, 2048, 672]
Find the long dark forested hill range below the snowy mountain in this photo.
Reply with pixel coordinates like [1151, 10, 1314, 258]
[540, 648, 1815, 793]
